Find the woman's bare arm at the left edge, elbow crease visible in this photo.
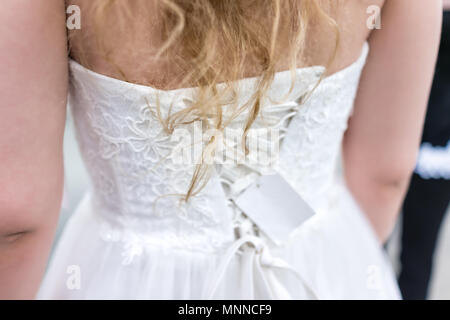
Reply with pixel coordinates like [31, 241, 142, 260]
[0, 0, 68, 299]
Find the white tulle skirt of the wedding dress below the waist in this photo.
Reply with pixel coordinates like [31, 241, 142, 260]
[37, 182, 400, 299]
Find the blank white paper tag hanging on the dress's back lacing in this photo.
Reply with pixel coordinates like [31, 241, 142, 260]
[234, 173, 315, 245]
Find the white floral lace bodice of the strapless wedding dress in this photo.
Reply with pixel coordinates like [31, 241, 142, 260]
[69, 44, 368, 262]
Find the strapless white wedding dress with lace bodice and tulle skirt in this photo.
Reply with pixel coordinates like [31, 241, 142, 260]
[37, 43, 400, 299]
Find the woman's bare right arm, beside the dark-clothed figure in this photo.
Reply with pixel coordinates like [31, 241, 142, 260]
[344, 0, 442, 241]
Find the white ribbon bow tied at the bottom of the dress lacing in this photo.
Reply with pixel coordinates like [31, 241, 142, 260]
[203, 235, 318, 300]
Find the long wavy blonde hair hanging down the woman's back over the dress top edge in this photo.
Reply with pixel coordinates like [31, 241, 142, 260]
[71, 0, 339, 200]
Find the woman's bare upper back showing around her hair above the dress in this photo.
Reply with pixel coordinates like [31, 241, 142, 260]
[68, 0, 384, 89]
